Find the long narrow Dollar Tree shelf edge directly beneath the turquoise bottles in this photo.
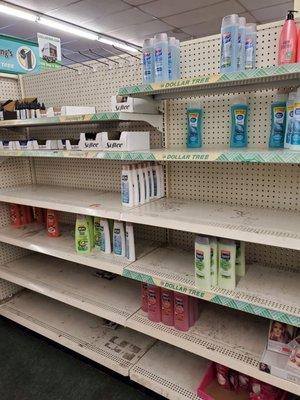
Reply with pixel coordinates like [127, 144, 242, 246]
[0, 146, 300, 164]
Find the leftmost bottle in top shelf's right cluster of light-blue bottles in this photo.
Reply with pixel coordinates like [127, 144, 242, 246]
[220, 14, 239, 72]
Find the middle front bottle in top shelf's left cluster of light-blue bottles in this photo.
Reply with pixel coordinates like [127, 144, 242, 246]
[154, 33, 169, 82]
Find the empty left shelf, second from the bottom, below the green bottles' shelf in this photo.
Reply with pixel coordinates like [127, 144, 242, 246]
[0, 254, 140, 325]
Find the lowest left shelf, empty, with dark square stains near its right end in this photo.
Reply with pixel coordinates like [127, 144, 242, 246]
[0, 291, 154, 376]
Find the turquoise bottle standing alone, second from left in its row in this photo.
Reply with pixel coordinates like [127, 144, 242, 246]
[230, 96, 248, 147]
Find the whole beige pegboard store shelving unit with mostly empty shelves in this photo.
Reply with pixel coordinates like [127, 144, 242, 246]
[0, 24, 300, 400]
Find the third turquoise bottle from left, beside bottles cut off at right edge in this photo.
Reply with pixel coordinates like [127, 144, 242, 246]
[269, 93, 286, 148]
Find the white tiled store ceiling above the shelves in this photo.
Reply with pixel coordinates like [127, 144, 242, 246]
[0, 0, 293, 61]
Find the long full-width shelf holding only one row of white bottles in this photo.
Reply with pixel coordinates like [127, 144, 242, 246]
[0, 185, 300, 250]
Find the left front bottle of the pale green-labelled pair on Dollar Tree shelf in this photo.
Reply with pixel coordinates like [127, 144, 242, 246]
[195, 236, 211, 289]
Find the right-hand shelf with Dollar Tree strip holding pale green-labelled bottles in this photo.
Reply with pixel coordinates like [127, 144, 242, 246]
[123, 246, 300, 327]
